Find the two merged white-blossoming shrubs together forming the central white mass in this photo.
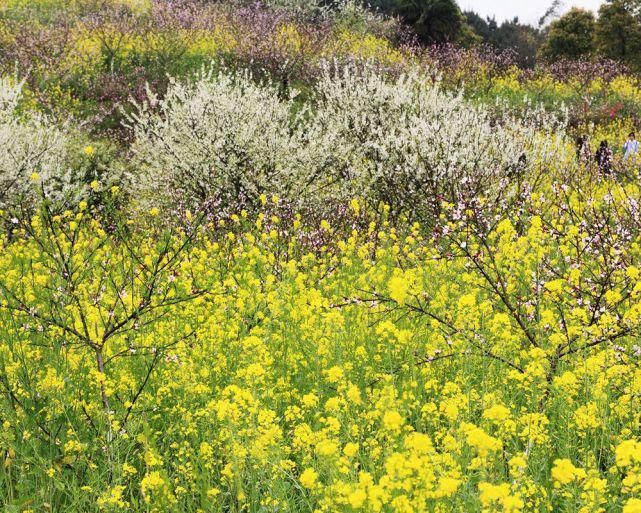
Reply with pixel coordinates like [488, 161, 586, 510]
[130, 64, 563, 214]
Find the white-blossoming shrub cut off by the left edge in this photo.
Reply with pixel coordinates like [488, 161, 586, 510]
[0, 78, 72, 209]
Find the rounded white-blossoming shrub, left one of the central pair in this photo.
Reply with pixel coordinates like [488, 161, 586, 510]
[129, 71, 296, 208]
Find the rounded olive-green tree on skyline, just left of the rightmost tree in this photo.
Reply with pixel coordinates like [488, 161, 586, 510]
[540, 7, 596, 61]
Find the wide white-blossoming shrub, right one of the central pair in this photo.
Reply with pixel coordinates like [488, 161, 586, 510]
[303, 68, 562, 213]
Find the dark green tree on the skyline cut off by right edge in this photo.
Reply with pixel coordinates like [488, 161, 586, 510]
[596, 0, 641, 70]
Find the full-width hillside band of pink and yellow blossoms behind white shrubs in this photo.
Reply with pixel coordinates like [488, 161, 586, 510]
[6, 0, 641, 134]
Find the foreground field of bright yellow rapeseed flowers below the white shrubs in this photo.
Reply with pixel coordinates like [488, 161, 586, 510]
[0, 178, 641, 513]
